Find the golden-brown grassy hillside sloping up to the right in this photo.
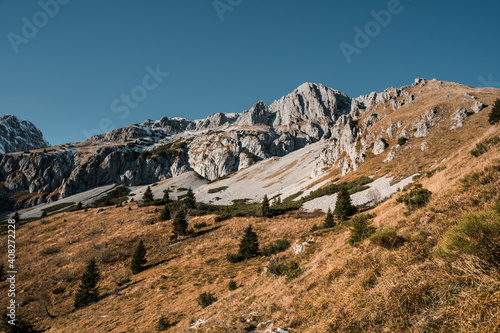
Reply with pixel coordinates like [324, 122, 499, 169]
[0, 92, 500, 332]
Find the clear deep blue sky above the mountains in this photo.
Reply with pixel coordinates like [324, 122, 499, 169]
[0, 0, 500, 144]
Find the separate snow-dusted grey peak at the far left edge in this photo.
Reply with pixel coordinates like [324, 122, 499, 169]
[0, 114, 50, 154]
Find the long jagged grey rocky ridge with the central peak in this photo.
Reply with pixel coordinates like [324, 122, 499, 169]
[0, 79, 492, 208]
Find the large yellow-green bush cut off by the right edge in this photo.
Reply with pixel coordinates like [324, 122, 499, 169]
[435, 203, 500, 269]
